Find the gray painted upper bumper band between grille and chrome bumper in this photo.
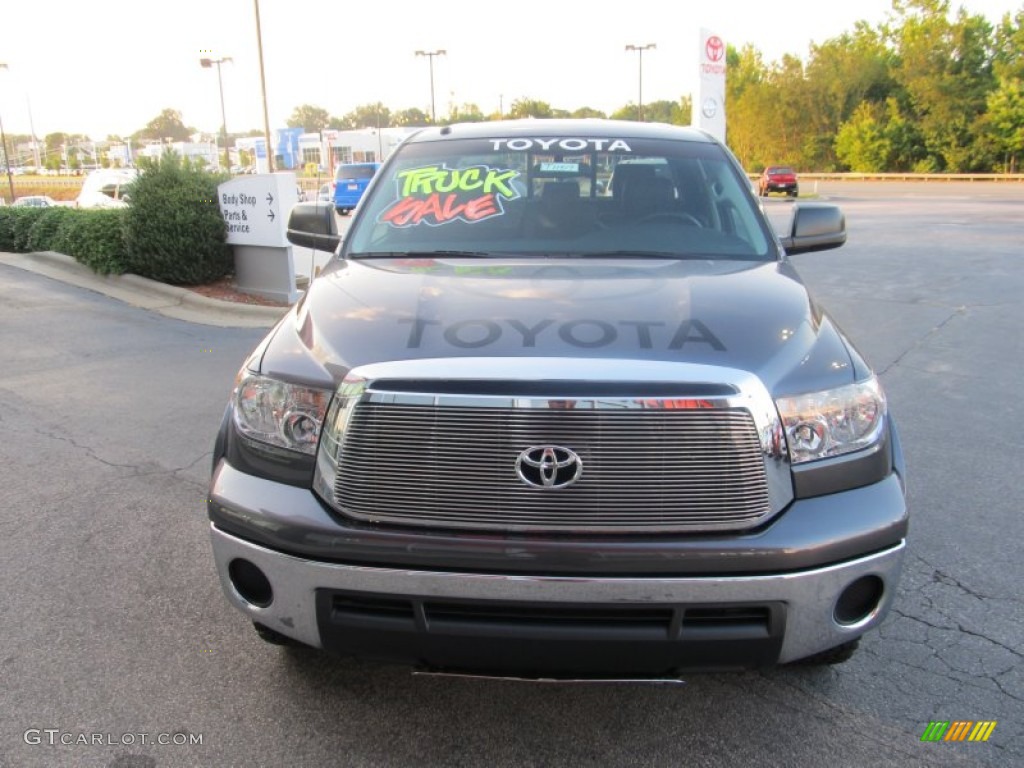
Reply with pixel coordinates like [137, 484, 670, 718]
[207, 456, 908, 578]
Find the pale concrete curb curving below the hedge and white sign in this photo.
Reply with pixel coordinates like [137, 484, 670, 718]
[0, 251, 289, 328]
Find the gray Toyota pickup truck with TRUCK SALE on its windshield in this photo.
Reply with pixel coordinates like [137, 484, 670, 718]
[208, 120, 907, 679]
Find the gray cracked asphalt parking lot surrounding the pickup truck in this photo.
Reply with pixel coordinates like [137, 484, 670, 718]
[0, 182, 1024, 768]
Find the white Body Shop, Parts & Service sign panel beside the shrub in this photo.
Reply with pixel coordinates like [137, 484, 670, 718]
[217, 172, 299, 247]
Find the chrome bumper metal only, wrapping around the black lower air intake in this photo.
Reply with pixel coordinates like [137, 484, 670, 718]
[211, 525, 905, 664]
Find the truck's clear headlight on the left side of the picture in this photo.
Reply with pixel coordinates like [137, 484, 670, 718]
[232, 370, 331, 456]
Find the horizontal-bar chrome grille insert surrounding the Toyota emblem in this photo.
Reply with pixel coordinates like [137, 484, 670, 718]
[334, 399, 772, 532]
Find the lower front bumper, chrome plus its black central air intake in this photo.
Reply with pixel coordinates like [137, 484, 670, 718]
[211, 524, 904, 675]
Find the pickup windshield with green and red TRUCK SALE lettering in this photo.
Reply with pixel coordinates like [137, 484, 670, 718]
[344, 138, 775, 260]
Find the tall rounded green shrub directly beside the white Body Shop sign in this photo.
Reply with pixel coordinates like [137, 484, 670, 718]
[125, 154, 233, 285]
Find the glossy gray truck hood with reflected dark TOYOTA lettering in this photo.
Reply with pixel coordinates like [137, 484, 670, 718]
[260, 258, 866, 395]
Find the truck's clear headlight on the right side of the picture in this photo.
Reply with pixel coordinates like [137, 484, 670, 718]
[775, 376, 886, 464]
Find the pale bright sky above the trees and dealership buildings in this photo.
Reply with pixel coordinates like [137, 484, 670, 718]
[0, 0, 1024, 139]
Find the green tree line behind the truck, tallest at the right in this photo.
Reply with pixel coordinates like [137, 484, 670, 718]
[289, 0, 1024, 173]
